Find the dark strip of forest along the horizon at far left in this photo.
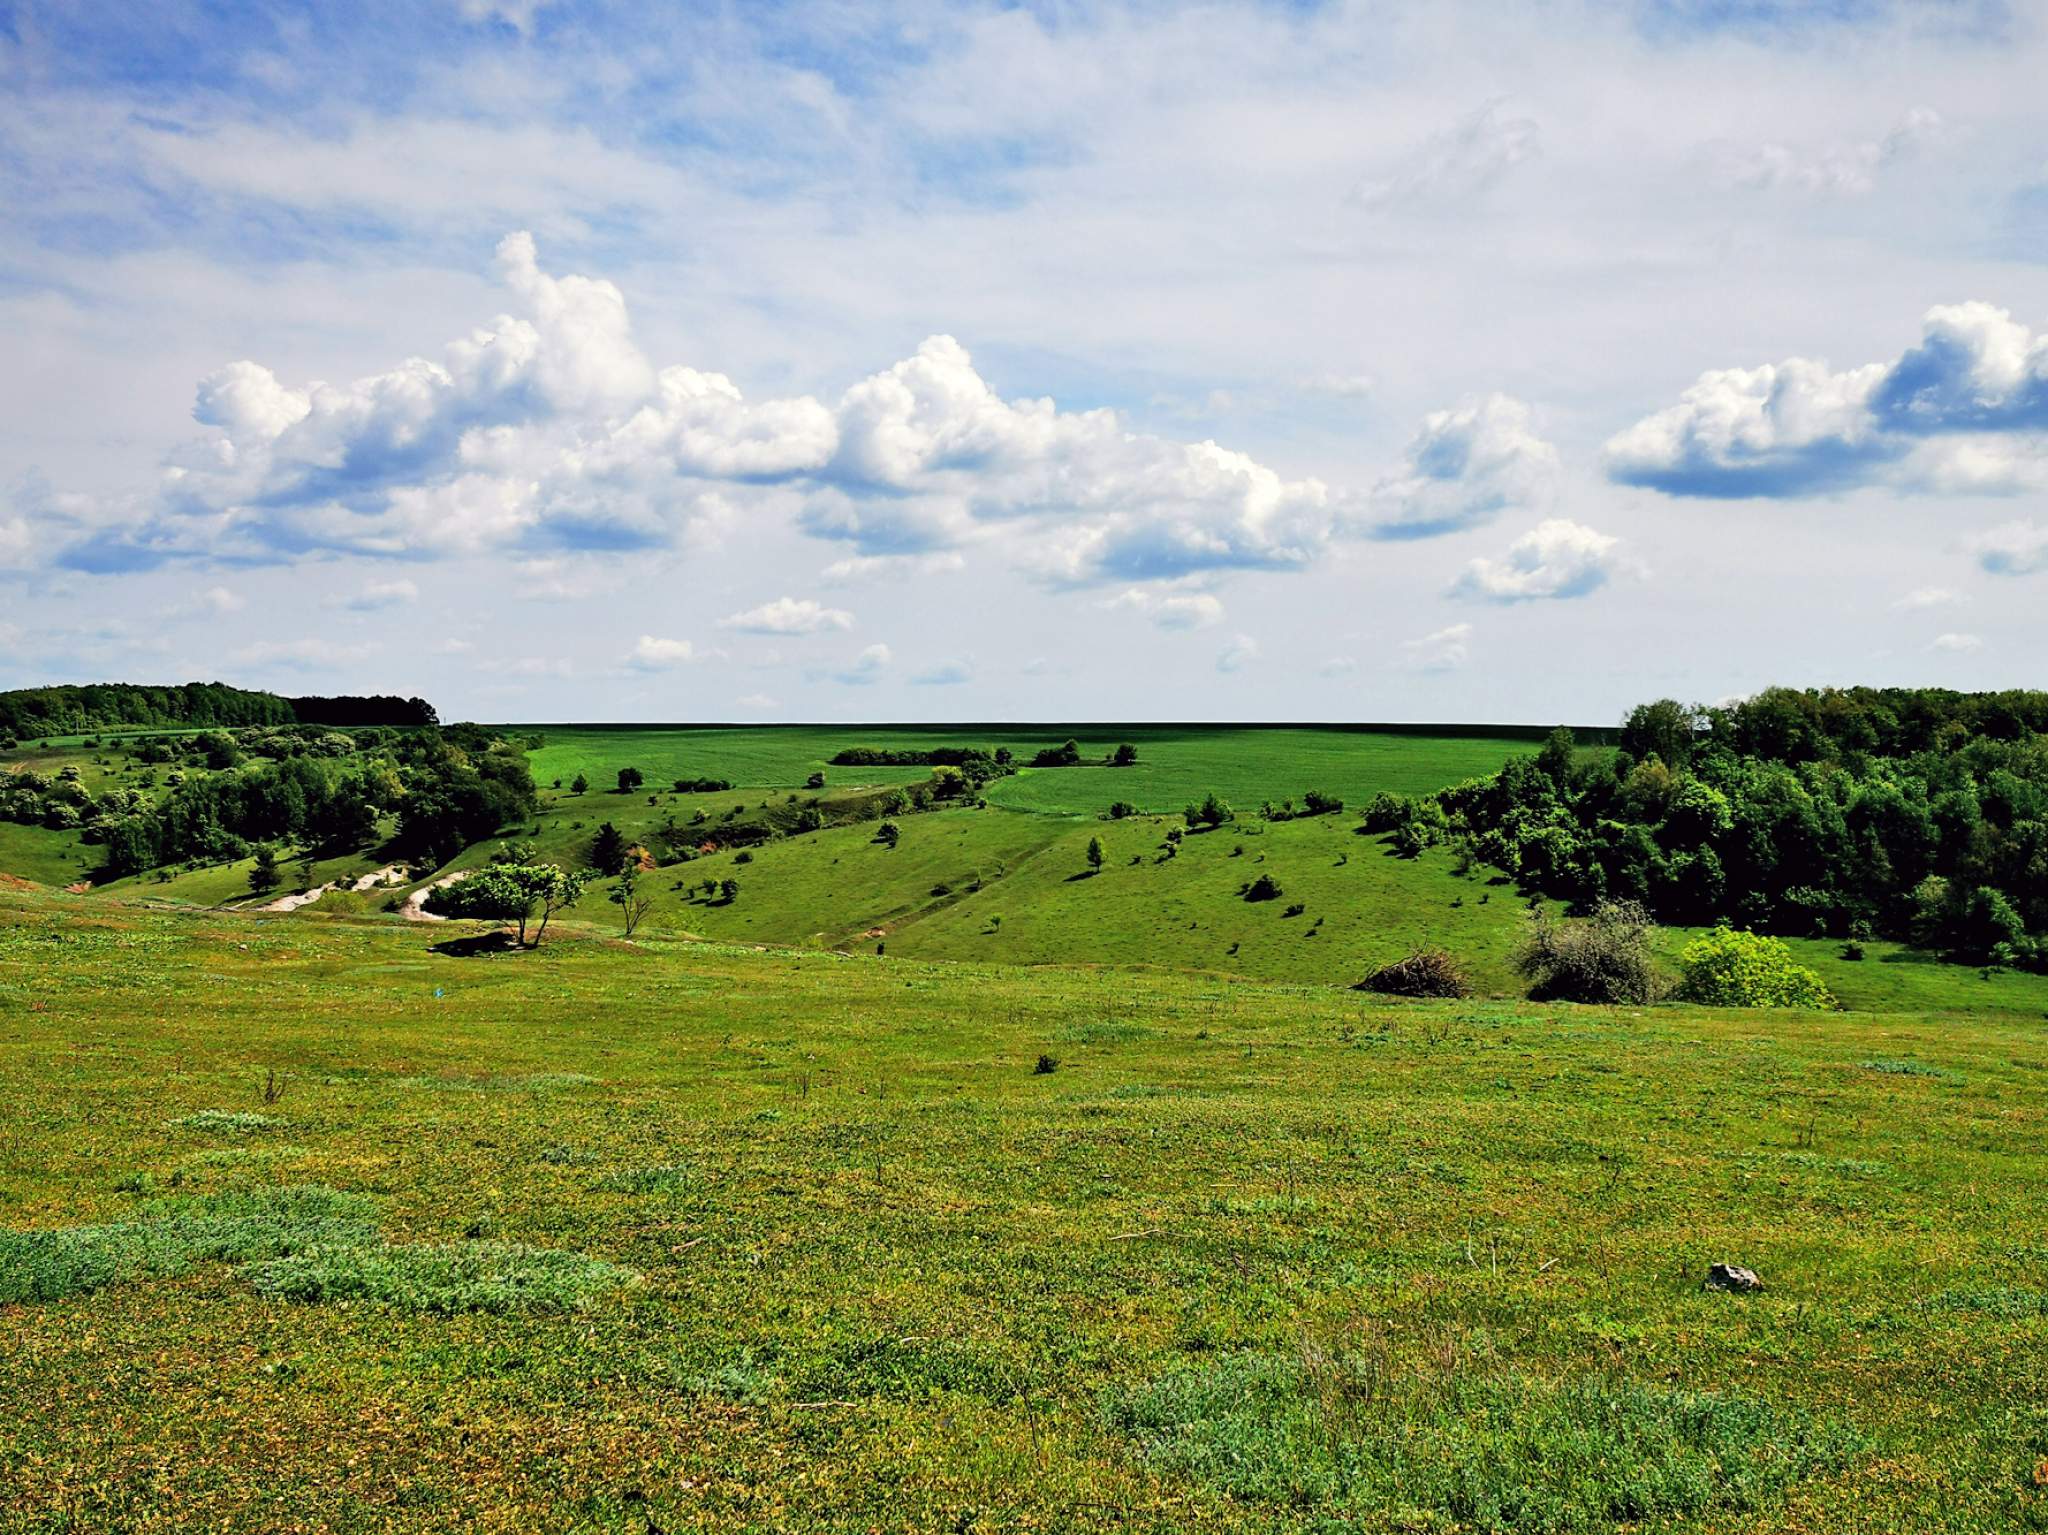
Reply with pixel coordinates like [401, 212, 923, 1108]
[0, 682, 438, 739]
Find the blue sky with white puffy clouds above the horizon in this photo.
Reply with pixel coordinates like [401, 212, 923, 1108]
[0, 0, 2048, 720]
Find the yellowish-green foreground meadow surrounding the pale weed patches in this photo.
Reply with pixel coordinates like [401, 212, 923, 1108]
[0, 888, 2048, 1535]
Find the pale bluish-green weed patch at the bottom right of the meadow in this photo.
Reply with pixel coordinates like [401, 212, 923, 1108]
[1104, 1355, 1853, 1535]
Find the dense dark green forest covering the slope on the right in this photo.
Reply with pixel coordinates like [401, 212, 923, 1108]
[1409, 688, 2048, 968]
